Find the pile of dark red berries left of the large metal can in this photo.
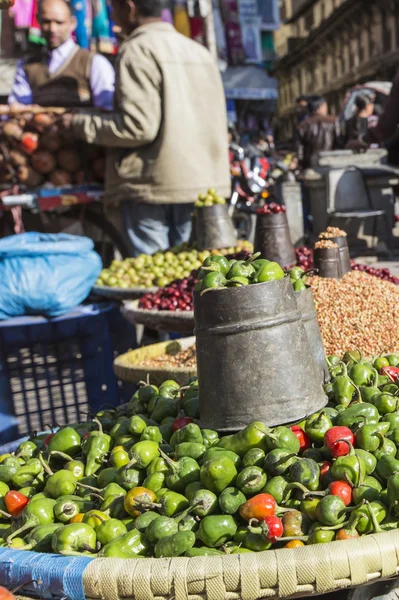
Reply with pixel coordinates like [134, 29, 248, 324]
[139, 250, 251, 311]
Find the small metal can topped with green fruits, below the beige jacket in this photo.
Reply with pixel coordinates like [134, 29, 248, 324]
[194, 204, 237, 250]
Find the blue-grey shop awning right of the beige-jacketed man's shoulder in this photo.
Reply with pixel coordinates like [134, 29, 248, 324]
[222, 65, 278, 100]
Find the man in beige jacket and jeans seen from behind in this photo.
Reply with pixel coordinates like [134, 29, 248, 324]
[64, 0, 230, 256]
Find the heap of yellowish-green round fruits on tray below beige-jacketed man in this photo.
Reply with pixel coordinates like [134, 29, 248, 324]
[96, 241, 253, 289]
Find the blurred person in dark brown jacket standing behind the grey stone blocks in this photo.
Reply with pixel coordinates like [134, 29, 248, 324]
[297, 98, 340, 169]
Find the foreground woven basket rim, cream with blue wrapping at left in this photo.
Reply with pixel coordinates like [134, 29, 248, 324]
[4, 530, 399, 600]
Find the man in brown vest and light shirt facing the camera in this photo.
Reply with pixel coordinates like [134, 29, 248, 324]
[8, 0, 115, 110]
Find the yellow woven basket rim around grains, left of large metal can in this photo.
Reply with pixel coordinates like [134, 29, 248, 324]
[114, 337, 197, 385]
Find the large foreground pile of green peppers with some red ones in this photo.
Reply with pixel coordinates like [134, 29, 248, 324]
[0, 352, 399, 558]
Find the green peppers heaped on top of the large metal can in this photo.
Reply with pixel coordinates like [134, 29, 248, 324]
[195, 253, 306, 294]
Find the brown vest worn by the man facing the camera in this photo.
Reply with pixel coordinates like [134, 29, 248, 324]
[24, 47, 93, 107]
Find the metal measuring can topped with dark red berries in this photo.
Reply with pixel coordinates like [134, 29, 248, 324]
[255, 213, 296, 267]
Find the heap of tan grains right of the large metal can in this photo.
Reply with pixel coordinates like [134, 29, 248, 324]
[309, 271, 399, 355]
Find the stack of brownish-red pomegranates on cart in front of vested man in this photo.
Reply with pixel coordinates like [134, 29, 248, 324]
[0, 106, 105, 189]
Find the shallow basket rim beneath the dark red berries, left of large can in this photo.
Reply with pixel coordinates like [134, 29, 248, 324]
[122, 300, 195, 334]
